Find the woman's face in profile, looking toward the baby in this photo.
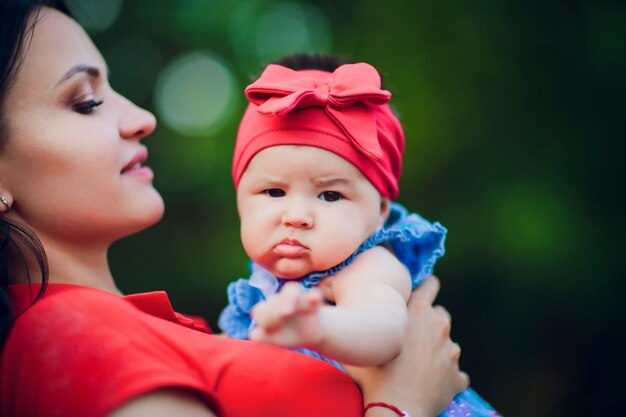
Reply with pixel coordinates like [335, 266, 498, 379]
[0, 8, 163, 244]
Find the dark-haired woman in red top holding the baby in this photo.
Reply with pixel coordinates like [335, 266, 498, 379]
[0, 0, 467, 417]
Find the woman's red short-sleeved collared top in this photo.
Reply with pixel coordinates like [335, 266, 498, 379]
[0, 284, 363, 417]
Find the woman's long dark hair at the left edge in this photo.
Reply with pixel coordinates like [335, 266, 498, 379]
[0, 0, 71, 343]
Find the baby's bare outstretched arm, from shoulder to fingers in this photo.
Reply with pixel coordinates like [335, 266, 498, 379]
[250, 247, 411, 366]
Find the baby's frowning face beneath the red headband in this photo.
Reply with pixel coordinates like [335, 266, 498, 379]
[237, 145, 389, 278]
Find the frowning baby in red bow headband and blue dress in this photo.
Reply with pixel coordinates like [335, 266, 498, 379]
[219, 56, 496, 416]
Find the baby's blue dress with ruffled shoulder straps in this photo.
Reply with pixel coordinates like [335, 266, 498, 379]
[218, 203, 500, 417]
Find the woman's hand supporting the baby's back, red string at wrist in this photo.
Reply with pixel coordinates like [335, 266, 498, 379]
[346, 277, 469, 417]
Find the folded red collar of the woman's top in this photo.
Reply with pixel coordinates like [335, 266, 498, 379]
[8, 284, 212, 334]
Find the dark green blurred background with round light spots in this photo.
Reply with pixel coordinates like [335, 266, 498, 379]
[66, 0, 626, 417]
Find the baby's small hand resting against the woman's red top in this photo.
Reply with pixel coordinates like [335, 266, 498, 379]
[250, 283, 323, 348]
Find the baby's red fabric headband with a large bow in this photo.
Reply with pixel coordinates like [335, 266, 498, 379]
[232, 63, 404, 199]
